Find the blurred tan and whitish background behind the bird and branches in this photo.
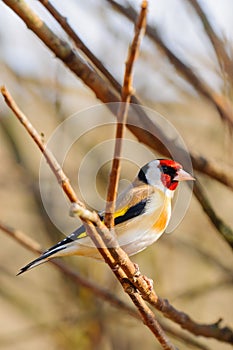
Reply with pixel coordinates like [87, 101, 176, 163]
[0, 0, 233, 350]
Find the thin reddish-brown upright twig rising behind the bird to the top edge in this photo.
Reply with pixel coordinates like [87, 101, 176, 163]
[104, 1, 148, 228]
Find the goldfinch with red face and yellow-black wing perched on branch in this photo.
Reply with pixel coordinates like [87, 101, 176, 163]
[17, 159, 195, 275]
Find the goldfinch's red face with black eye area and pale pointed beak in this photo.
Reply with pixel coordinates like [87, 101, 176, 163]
[159, 159, 195, 191]
